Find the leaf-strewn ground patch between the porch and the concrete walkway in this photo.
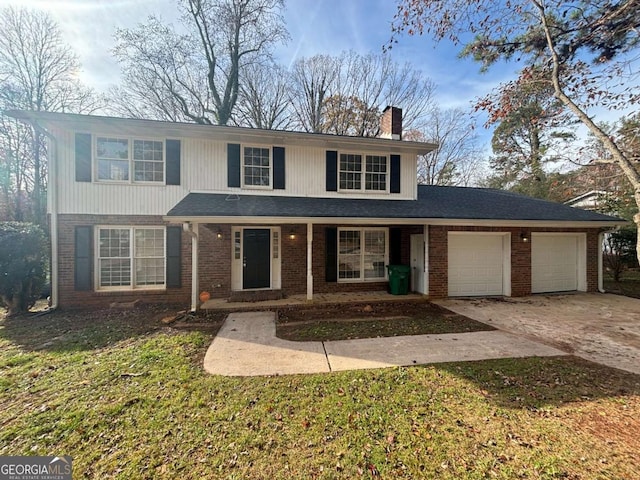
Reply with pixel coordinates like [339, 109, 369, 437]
[276, 301, 494, 341]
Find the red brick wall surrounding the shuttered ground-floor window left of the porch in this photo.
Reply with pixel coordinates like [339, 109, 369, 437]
[58, 214, 191, 308]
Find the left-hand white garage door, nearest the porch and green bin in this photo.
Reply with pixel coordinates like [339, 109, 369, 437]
[448, 233, 508, 297]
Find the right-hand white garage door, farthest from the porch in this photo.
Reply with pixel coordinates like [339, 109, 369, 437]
[531, 234, 580, 293]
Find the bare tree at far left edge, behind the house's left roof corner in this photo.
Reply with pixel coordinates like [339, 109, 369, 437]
[0, 8, 102, 225]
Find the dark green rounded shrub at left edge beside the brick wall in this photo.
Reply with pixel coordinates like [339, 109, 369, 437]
[0, 222, 47, 316]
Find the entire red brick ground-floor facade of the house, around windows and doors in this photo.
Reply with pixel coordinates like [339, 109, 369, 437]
[58, 215, 599, 308]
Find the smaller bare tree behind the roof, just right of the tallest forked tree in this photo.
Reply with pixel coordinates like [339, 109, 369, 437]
[232, 65, 293, 130]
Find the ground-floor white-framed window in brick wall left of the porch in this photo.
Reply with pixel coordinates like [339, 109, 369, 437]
[95, 226, 166, 290]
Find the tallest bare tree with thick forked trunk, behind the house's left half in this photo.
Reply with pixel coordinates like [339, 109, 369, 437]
[114, 0, 288, 125]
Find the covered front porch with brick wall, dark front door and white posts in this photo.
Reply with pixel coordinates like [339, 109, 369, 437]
[183, 217, 428, 310]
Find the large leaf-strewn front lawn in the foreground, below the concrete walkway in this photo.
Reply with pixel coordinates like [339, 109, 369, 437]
[0, 310, 640, 480]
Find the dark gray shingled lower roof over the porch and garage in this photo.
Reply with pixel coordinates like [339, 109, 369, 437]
[167, 185, 624, 223]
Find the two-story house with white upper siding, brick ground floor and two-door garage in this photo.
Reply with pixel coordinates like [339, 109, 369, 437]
[10, 108, 623, 308]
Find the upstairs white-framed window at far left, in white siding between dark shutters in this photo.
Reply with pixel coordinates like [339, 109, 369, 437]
[94, 136, 165, 183]
